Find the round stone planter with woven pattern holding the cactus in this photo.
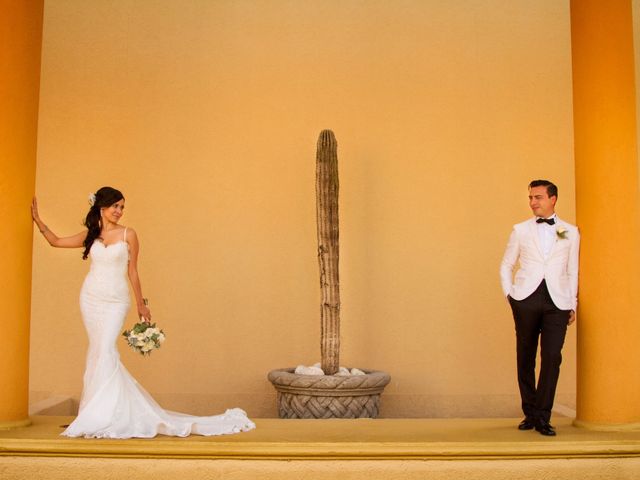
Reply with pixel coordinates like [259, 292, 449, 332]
[268, 368, 391, 418]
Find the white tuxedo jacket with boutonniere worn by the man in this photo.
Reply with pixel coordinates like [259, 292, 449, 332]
[500, 216, 580, 310]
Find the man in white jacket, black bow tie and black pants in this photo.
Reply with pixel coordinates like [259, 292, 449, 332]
[500, 180, 580, 436]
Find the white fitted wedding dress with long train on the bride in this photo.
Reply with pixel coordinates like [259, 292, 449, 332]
[62, 229, 255, 438]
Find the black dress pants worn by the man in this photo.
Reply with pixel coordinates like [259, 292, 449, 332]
[509, 280, 571, 422]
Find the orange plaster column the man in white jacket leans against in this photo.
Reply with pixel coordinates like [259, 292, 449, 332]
[571, 0, 640, 429]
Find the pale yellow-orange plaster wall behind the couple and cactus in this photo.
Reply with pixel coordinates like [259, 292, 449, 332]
[31, 0, 575, 416]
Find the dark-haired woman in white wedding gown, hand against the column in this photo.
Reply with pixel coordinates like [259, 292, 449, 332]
[31, 187, 255, 438]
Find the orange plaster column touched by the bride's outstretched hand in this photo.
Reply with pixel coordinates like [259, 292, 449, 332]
[0, 0, 44, 429]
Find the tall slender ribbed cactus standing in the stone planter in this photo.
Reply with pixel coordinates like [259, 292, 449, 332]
[316, 130, 340, 375]
